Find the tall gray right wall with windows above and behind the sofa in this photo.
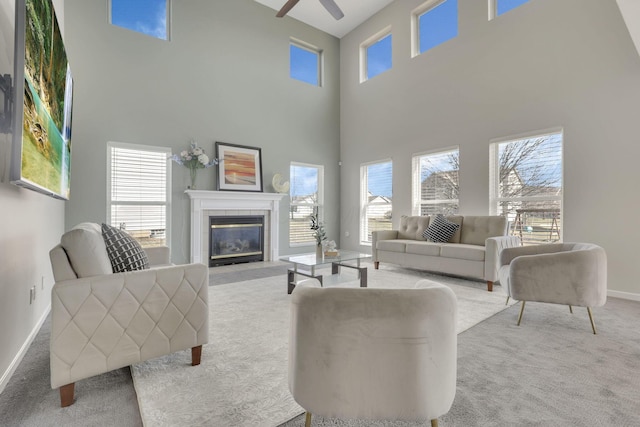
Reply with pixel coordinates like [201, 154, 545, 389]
[340, 0, 640, 297]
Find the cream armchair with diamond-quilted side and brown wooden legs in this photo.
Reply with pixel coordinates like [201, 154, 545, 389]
[49, 223, 209, 406]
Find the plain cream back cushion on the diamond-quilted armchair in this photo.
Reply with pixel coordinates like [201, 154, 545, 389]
[60, 222, 113, 277]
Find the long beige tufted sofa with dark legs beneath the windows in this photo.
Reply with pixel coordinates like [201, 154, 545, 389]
[372, 215, 520, 292]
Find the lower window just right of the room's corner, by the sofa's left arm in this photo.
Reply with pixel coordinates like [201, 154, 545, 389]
[360, 160, 393, 245]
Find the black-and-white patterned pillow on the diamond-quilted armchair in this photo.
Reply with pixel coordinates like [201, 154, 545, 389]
[102, 224, 149, 273]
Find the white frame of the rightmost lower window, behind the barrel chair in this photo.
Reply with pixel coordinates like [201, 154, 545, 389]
[489, 127, 565, 243]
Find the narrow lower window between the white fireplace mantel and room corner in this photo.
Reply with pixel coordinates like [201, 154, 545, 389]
[289, 163, 324, 246]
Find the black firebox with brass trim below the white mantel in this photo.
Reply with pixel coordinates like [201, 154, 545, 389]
[209, 215, 264, 267]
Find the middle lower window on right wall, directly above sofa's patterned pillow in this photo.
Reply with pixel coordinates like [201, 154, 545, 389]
[412, 147, 460, 215]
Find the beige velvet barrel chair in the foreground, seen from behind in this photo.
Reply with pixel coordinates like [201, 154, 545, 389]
[289, 279, 457, 426]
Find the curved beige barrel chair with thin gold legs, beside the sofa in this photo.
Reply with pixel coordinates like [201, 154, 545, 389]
[498, 243, 607, 334]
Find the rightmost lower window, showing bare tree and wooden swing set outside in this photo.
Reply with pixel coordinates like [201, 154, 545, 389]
[490, 131, 563, 244]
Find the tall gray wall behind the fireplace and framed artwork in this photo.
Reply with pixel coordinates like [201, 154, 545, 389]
[65, 0, 340, 263]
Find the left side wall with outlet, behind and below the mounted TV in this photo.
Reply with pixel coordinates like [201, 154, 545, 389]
[0, 0, 65, 391]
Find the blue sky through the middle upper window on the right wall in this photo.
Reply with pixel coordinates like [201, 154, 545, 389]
[418, 0, 458, 53]
